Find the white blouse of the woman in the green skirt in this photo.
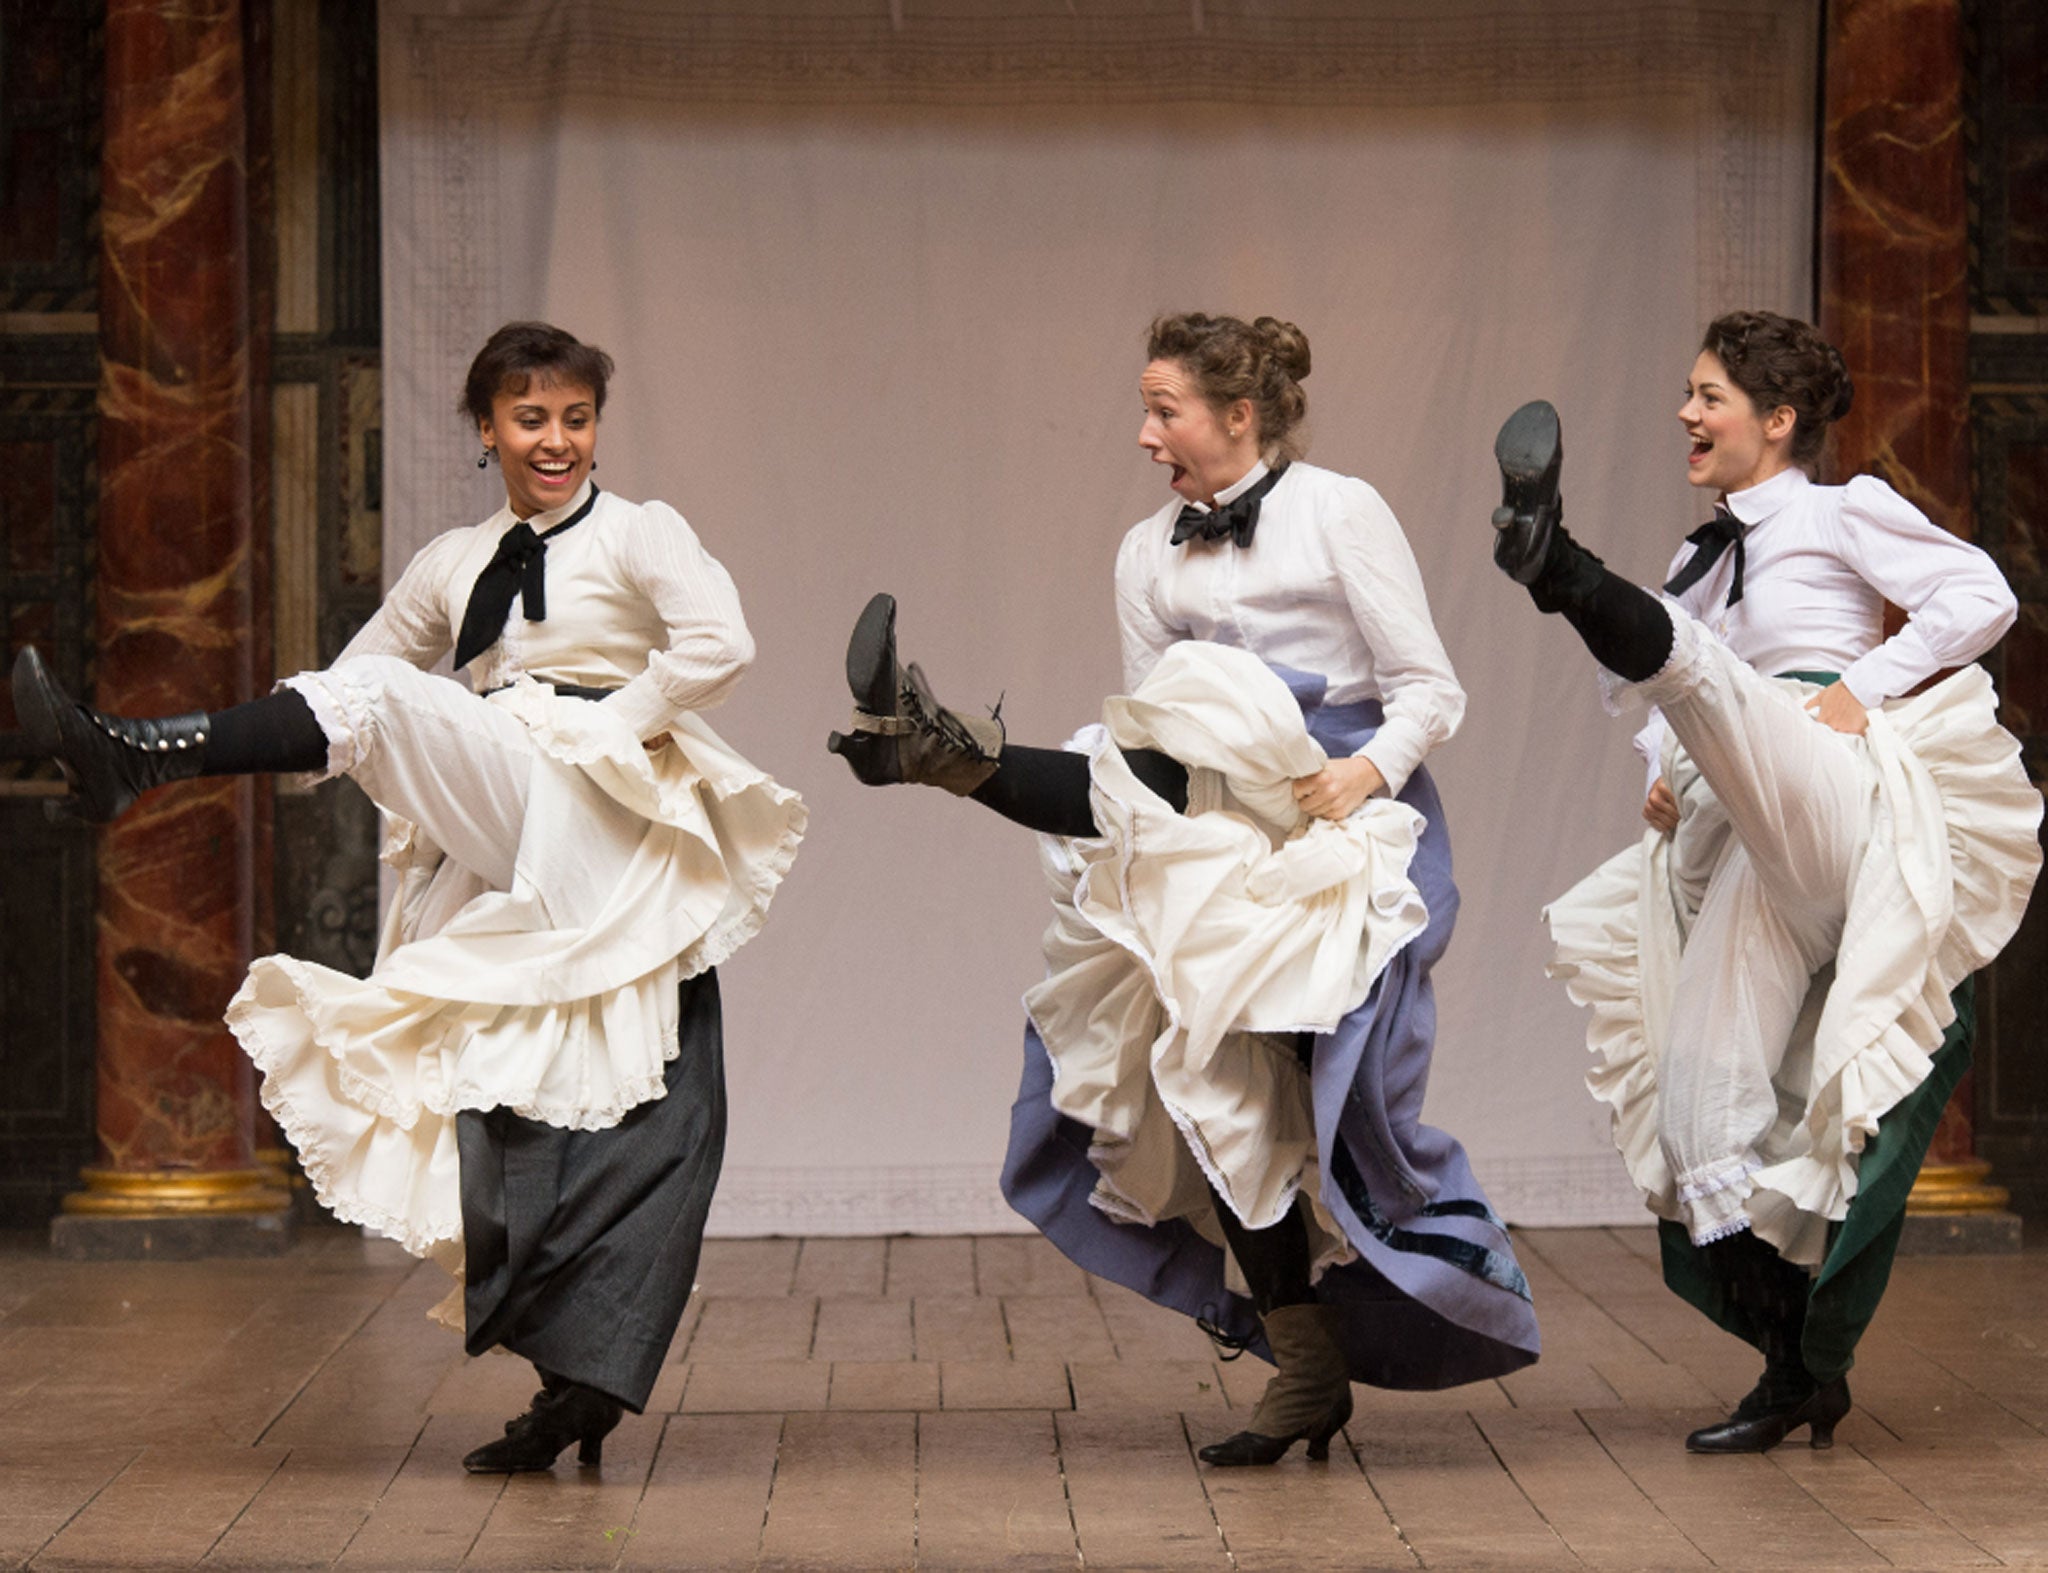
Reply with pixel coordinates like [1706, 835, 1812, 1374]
[1636, 467, 2019, 780]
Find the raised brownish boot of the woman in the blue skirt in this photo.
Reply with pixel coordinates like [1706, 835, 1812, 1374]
[825, 596, 1004, 797]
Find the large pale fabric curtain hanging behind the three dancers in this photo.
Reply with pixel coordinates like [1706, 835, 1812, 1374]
[379, 0, 1817, 1233]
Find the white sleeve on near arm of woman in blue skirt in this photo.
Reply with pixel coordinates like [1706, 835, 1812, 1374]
[1323, 481, 1464, 795]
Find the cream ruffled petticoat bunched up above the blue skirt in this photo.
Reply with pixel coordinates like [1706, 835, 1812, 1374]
[1024, 641, 1430, 1266]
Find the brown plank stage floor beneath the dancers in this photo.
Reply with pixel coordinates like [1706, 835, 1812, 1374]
[0, 1229, 2048, 1569]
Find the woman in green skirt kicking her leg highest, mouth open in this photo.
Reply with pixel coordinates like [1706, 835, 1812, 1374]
[1493, 311, 2042, 1452]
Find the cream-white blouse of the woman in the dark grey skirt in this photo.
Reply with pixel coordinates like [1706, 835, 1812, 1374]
[342, 481, 754, 739]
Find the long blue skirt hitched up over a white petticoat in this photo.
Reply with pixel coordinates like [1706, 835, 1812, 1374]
[1004, 670, 1538, 1389]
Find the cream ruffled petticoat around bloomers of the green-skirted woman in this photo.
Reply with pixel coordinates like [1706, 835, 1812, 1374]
[1544, 666, 2042, 1266]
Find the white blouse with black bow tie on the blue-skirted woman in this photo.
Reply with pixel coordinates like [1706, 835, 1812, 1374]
[1116, 463, 1464, 795]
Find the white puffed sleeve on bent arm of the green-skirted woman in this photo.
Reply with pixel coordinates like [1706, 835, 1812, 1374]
[1831, 475, 2019, 705]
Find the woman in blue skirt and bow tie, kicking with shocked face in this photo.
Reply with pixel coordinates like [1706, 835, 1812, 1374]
[831, 313, 1536, 1464]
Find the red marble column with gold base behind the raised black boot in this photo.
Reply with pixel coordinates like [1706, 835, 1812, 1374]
[51, 0, 291, 1256]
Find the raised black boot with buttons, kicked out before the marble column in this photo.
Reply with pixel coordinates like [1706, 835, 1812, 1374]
[14, 647, 207, 823]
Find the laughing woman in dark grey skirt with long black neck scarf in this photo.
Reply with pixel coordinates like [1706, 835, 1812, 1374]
[14, 322, 805, 1473]
